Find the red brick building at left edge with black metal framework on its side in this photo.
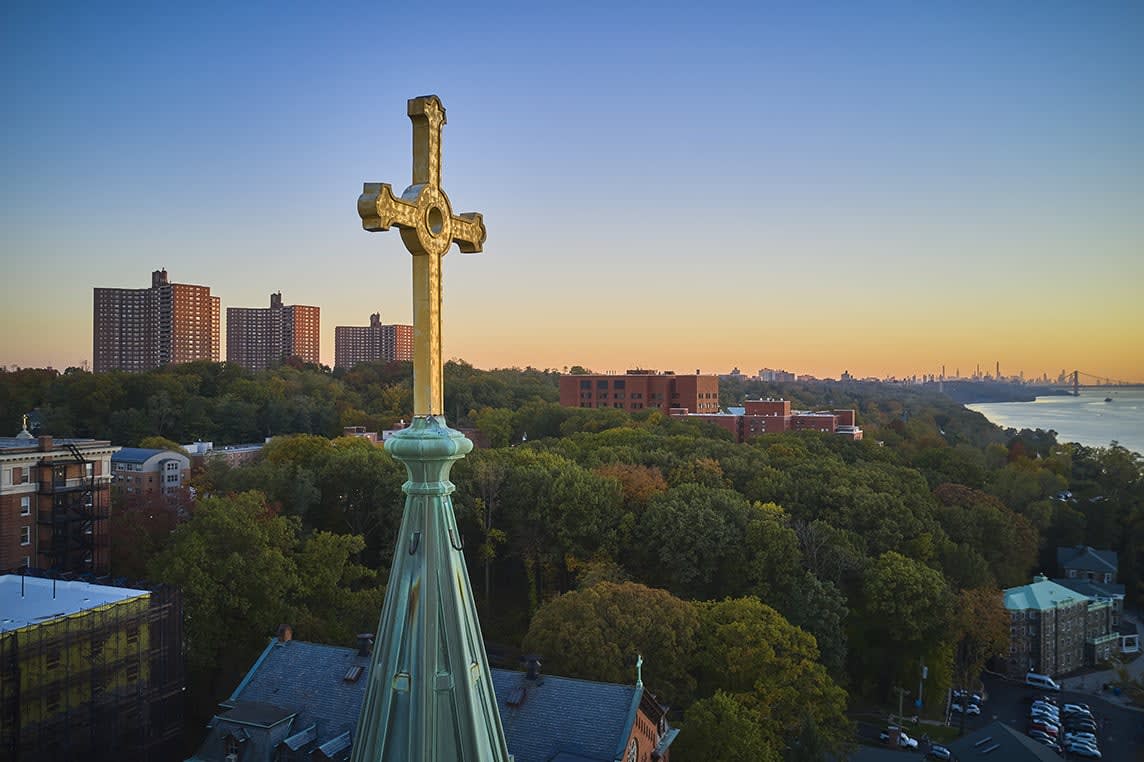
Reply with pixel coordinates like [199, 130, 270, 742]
[0, 429, 119, 573]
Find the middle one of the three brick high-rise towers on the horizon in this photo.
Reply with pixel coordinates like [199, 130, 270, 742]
[227, 292, 321, 371]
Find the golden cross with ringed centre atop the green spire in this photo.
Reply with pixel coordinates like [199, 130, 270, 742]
[358, 95, 485, 415]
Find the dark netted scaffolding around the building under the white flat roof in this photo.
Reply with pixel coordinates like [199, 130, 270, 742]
[0, 577, 184, 762]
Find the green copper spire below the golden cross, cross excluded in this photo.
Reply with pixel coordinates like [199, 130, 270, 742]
[352, 416, 511, 762]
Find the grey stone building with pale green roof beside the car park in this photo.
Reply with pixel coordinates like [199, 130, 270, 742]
[1004, 576, 1120, 677]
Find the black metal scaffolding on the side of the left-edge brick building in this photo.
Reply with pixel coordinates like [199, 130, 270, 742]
[37, 443, 110, 573]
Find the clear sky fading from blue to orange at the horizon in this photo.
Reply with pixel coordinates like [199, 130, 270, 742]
[0, 0, 1144, 381]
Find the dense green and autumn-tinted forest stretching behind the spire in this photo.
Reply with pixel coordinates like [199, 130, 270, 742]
[0, 362, 1144, 762]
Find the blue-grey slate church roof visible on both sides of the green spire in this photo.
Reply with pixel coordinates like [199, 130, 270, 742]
[192, 640, 658, 762]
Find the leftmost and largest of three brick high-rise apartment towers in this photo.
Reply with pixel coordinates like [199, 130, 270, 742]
[92, 270, 220, 373]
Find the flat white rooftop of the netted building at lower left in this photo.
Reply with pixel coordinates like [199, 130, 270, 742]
[0, 574, 151, 633]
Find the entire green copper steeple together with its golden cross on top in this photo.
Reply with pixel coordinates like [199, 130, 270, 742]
[351, 95, 513, 762]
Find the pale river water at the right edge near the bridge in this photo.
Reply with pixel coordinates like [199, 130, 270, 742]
[966, 387, 1144, 453]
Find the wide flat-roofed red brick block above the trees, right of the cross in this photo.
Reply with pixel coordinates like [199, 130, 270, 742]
[561, 370, 718, 413]
